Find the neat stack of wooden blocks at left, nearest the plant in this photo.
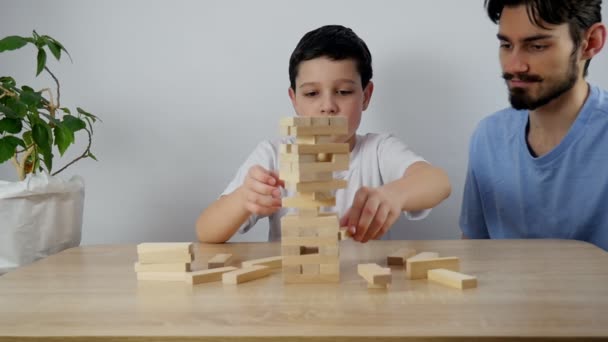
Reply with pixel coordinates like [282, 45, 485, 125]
[135, 242, 194, 280]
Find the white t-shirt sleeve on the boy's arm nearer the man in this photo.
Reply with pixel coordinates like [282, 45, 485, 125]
[378, 134, 431, 220]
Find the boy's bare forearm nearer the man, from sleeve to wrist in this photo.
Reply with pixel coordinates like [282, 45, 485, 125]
[384, 162, 452, 211]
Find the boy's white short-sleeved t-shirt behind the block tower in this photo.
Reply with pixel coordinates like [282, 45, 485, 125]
[221, 133, 430, 241]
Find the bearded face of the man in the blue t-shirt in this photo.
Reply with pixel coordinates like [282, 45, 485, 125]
[498, 5, 582, 110]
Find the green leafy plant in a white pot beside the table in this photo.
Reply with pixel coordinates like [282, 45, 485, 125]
[0, 31, 98, 272]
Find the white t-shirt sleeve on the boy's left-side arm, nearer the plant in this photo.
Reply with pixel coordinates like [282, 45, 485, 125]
[220, 140, 277, 234]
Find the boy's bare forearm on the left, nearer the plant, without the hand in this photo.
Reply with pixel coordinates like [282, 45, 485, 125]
[196, 188, 251, 243]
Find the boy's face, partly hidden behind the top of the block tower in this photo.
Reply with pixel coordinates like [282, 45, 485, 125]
[289, 57, 373, 149]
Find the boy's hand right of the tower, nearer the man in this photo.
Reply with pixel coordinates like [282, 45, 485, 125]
[340, 187, 401, 243]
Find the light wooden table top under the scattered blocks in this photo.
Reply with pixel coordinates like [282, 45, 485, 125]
[0, 240, 608, 341]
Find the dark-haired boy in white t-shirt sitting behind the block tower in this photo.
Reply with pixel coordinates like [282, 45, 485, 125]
[196, 25, 451, 243]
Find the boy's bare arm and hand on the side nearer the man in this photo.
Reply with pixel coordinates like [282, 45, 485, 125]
[341, 161, 451, 242]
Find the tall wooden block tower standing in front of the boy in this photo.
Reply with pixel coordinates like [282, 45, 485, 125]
[279, 116, 350, 283]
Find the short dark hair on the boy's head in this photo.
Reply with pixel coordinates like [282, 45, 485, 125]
[289, 25, 372, 91]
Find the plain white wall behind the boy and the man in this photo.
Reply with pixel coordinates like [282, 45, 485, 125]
[0, 0, 608, 244]
